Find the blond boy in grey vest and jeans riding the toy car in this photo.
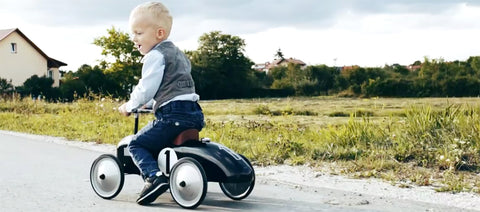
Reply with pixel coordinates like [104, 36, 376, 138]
[119, 2, 204, 205]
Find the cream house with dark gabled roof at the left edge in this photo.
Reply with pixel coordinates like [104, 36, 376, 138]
[0, 28, 67, 87]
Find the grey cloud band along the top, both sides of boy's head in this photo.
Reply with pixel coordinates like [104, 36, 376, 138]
[0, 0, 472, 31]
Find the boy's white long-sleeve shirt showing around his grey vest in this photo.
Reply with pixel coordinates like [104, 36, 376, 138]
[126, 41, 200, 112]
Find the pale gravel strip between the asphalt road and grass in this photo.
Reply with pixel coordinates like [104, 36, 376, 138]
[0, 130, 480, 211]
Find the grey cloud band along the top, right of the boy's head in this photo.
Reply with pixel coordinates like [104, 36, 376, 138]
[164, 0, 469, 28]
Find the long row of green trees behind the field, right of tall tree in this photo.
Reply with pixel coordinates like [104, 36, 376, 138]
[269, 57, 480, 97]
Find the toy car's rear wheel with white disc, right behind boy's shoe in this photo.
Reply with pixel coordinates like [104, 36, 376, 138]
[170, 157, 207, 209]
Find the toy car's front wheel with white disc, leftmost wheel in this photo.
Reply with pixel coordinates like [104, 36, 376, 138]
[90, 154, 124, 199]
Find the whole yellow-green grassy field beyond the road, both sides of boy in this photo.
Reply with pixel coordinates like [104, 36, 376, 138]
[0, 97, 480, 192]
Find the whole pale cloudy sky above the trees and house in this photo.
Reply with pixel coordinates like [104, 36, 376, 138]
[0, 0, 480, 71]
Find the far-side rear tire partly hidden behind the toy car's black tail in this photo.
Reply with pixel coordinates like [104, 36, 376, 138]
[219, 155, 255, 200]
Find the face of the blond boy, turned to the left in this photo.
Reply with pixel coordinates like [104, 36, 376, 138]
[130, 14, 165, 55]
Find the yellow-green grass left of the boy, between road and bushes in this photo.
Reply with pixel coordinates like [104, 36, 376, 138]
[0, 99, 147, 144]
